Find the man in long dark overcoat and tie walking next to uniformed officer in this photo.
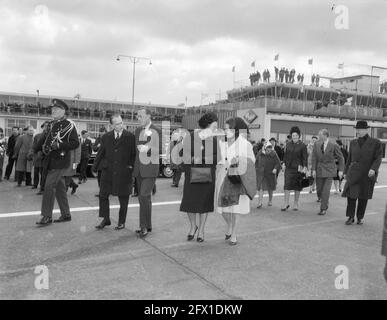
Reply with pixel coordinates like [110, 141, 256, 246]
[93, 114, 136, 230]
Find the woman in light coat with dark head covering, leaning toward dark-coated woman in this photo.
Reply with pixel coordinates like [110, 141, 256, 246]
[215, 118, 256, 245]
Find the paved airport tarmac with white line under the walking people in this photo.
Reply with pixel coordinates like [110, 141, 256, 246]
[0, 164, 387, 300]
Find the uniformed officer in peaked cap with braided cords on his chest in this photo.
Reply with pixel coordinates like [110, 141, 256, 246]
[36, 99, 79, 226]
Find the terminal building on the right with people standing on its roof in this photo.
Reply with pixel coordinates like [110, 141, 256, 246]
[183, 75, 387, 158]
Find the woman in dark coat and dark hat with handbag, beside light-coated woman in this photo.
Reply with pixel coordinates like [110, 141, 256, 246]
[180, 112, 218, 242]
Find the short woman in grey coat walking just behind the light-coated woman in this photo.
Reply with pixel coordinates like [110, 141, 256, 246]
[255, 142, 281, 209]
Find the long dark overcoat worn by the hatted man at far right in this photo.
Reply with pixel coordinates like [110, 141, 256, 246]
[342, 136, 382, 199]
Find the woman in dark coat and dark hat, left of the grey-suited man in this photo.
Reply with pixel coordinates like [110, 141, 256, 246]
[281, 127, 308, 211]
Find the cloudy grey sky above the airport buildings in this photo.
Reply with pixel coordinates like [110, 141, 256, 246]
[0, 0, 387, 106]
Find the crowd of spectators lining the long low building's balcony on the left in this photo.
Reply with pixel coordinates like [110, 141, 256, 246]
[0, 102, 183, 123]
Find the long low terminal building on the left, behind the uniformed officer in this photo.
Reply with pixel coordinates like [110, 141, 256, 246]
[0, 92, 185, 138]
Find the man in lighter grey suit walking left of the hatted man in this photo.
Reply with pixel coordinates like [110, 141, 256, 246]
[312, 129, 344, 216]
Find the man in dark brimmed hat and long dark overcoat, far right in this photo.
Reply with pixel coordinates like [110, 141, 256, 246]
[342, 121, 383, 225]
